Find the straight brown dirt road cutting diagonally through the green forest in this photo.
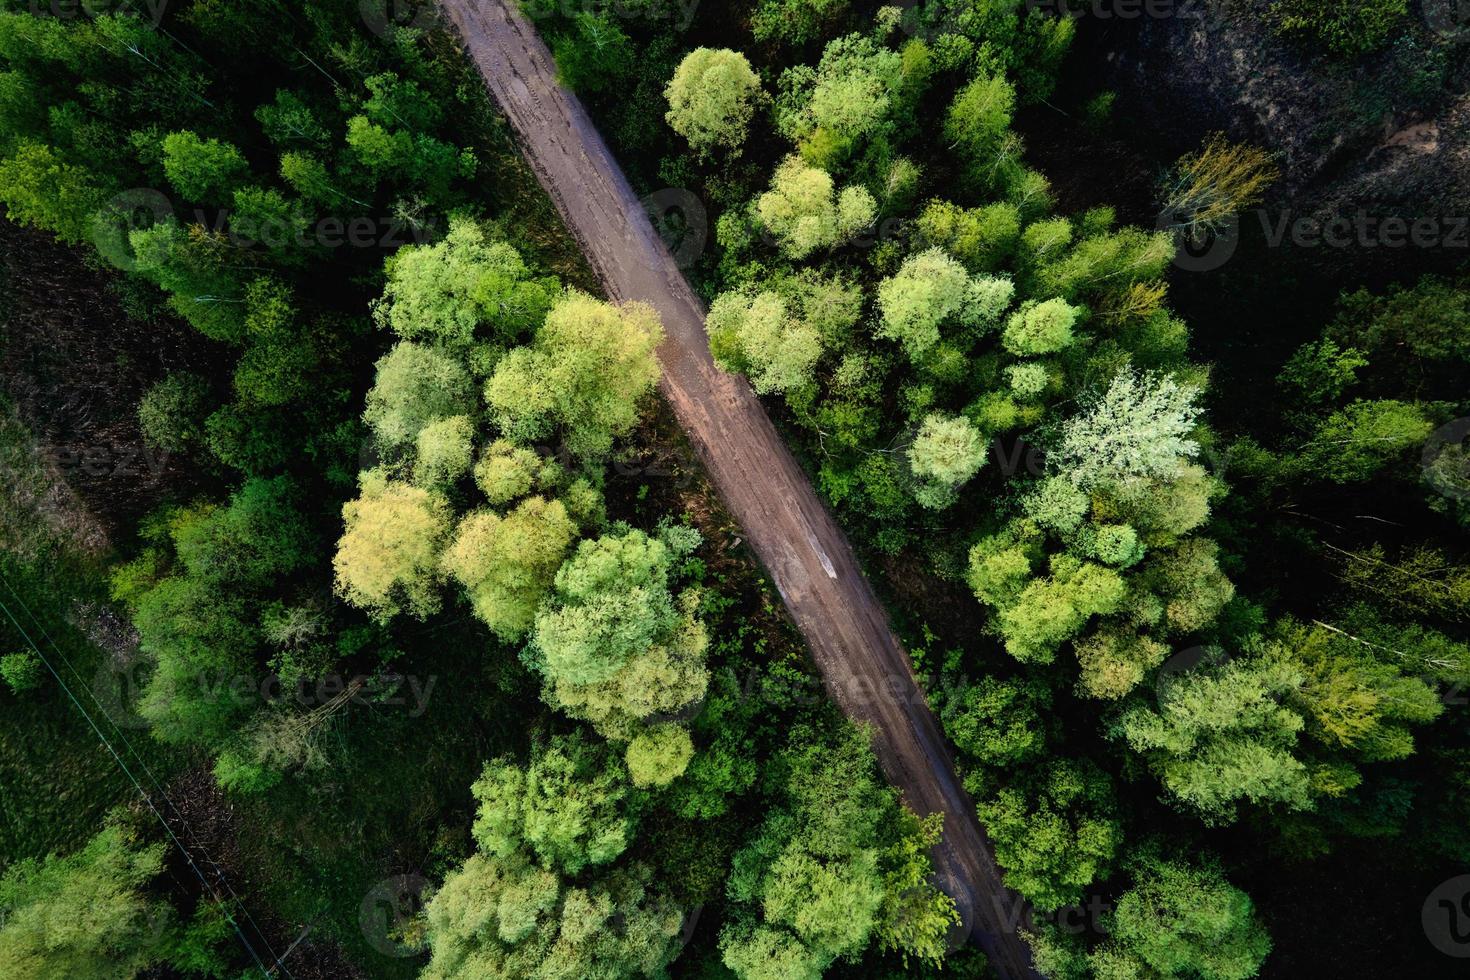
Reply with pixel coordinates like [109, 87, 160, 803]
[441, 0, 1038, 979]
